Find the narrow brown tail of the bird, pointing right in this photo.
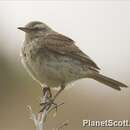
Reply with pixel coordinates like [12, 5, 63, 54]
[91, 73, 128, 90]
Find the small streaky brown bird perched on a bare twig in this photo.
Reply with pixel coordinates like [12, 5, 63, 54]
[18, 21, 128, 96]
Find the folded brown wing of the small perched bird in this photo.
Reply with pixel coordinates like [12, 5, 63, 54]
[43, 34, 99, 69]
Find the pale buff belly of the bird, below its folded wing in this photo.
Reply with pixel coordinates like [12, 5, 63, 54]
[23, 47, 87, 87]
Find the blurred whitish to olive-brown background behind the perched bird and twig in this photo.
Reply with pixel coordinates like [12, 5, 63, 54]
[0, 1, 130, 130]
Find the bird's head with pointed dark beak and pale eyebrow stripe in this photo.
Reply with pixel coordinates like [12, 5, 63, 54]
[18, 21, 52, 38]
